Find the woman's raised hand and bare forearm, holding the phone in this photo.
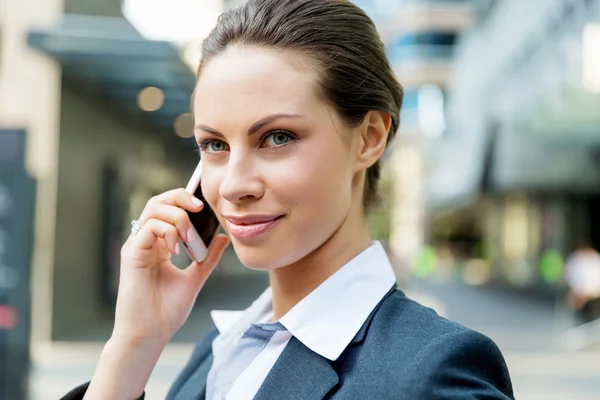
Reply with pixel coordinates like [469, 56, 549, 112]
[84, 189, 229, 400]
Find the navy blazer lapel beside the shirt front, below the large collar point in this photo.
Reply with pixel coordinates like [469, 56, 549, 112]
[254, 337, 339, 400]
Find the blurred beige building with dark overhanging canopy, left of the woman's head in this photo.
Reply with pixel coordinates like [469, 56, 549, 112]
[0, 0, 206, 350]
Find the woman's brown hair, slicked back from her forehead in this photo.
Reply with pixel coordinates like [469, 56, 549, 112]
[198, 0, 403, 210]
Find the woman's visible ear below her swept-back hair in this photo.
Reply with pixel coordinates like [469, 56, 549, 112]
[356, 111, 392, 171]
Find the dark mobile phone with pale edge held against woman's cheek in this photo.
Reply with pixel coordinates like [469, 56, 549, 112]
[182, 162, 219, 262]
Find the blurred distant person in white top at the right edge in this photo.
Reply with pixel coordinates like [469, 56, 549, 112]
[565, 244, 600, 323]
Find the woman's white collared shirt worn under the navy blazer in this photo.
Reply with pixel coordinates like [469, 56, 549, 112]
[211, 242, 396, 400]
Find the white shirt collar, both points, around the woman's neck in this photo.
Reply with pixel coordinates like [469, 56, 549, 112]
[211, 242, 396, 361]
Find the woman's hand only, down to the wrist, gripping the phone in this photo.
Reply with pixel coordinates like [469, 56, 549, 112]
[113, 189, 229, 346]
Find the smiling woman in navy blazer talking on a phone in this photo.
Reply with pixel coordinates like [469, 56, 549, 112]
[67, 0, 513, 400]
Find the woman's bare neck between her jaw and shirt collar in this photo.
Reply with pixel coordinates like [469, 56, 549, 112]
[269, 208, 371, 321]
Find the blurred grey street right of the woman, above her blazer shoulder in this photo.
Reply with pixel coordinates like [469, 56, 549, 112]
[414, 285, 600, 400]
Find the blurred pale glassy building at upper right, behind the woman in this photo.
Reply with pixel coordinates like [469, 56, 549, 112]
[427, 0, 600, 289]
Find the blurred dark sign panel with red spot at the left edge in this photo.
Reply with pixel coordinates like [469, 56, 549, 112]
[0, 129, 34, 399]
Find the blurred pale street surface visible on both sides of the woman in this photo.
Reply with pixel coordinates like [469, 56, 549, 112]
[31, 277, 600, 400]
